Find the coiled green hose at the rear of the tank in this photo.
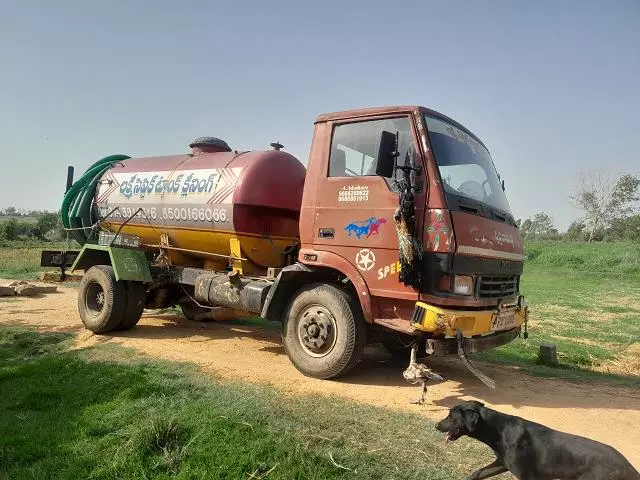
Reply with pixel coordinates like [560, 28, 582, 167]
[60, 155, 131, 245]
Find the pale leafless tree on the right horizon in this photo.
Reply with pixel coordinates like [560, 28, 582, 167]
[569, 170, 640, 241]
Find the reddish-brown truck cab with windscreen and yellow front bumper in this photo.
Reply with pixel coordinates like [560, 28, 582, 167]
[299, 106, 526, 364]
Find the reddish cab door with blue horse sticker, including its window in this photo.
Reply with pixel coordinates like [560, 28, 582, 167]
[313, 114, 426, 301]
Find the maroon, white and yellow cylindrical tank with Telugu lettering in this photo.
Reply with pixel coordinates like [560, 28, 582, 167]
[95, 142, 306, 269]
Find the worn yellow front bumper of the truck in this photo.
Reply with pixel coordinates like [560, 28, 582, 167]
[411, 298, 529, 337]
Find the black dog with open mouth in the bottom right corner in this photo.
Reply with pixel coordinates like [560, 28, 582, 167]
[436, 401, 640, 480]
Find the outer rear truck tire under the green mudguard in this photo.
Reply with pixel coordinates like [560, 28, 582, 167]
[78, 265, 127, 333]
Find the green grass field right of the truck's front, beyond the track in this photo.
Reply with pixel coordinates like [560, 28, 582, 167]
[479, 243, 640, 386]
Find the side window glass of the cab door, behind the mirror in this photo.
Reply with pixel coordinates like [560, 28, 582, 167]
[329, 117, 415, 177]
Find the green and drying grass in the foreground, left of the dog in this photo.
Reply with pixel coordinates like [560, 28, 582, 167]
[0, 328, 489, 480]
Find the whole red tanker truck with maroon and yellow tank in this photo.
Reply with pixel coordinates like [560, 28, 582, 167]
[42, 106, 528, 379]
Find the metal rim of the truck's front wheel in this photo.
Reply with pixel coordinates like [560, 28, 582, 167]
[297, 305, 337, 358]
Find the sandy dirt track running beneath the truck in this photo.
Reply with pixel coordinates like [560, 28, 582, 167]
[0, 281, 640, 469]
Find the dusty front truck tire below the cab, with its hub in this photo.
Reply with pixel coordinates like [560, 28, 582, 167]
[282, 284, 367, 379]
